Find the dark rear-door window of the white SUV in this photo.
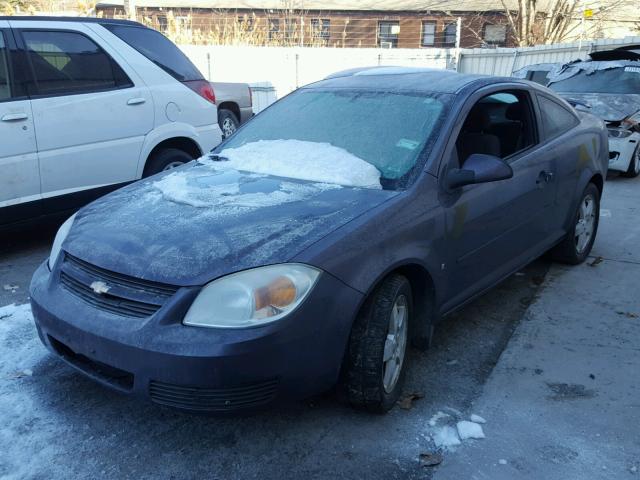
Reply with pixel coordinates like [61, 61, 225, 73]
[22, 30, 133, 95]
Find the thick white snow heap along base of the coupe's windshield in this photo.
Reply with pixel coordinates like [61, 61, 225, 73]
[219, 140, 382, 188]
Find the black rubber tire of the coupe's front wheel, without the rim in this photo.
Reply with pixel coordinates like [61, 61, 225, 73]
[342, 274, 413, 413]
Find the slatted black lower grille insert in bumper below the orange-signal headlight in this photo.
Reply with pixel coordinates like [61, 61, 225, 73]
[149, 379, 278, 412]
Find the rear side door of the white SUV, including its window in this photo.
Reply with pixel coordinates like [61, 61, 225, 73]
[14, 21, 154, 209]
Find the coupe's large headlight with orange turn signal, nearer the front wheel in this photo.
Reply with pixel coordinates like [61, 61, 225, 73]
[183, 263, 320, 328]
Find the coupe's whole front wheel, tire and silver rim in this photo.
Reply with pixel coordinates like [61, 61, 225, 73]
[344, 275, 413, 413]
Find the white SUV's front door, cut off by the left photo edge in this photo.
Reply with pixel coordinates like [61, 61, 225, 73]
[0, 20, 40, 225]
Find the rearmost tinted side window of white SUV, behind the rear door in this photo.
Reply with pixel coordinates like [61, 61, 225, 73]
[103, 24, 204, 82]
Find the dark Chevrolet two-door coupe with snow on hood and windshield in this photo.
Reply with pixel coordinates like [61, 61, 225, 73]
[31, 67, 608, 412]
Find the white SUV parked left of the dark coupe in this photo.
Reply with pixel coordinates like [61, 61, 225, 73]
[0, 17, 221, 226]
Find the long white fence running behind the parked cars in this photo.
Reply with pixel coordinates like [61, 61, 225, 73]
[180, 37, 640, 113]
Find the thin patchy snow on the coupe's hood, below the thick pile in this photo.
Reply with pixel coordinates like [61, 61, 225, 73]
[154, 170, 340, 211]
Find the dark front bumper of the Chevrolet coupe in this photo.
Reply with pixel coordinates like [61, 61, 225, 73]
[30, 264, 362, 413]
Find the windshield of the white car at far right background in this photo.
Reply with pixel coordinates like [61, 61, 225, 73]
[549, 67, 640, 93]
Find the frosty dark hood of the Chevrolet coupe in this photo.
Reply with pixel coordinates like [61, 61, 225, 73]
[63, 162, 397, 286]
